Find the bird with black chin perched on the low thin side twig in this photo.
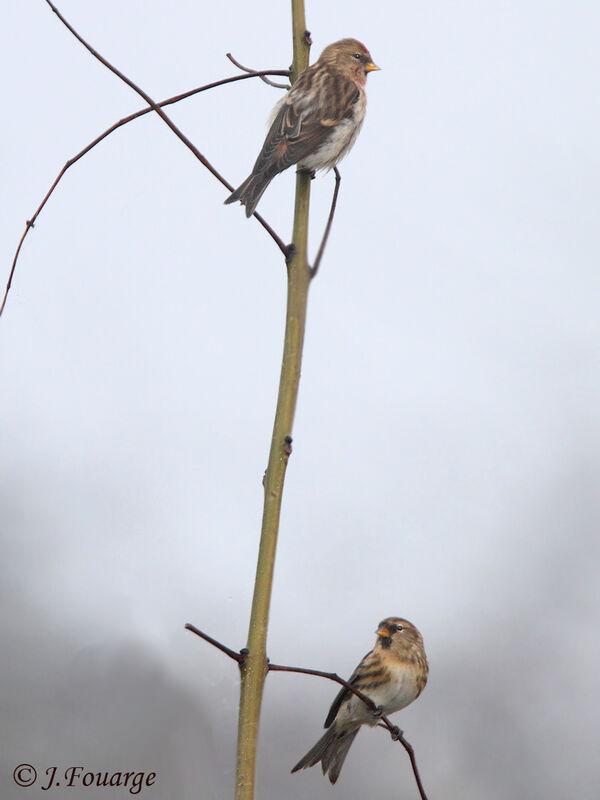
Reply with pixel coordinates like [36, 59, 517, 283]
[292, 617, 429, 783]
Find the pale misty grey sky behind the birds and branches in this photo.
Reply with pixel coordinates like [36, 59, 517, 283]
[0, 0, 600, 800]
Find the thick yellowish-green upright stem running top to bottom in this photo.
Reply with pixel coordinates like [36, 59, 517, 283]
[235, 0, 310, 800]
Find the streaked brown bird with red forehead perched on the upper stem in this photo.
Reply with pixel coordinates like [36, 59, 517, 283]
[225, 39, 379, 217]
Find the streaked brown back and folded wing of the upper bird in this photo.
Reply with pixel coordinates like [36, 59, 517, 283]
[252, 68, 360, 175]
